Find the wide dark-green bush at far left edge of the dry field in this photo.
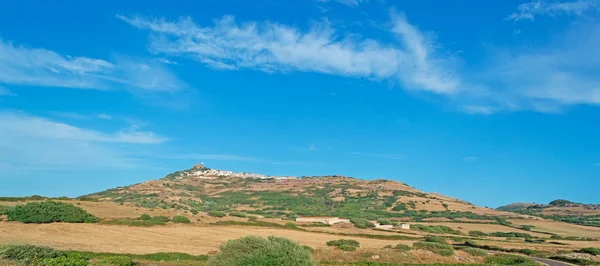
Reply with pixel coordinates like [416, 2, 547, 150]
[6, 201, 100, 223]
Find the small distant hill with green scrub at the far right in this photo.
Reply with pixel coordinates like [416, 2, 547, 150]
[498, 199, 600, 227]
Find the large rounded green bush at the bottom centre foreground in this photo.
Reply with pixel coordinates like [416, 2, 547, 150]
[208, 236, 315, 266]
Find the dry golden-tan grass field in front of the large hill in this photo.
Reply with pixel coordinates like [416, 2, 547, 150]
[0, 222, 412, 255]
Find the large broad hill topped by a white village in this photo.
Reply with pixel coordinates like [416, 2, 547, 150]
[81, 165, 515, 223]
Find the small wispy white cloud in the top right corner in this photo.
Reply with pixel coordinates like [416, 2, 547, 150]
[506, 0, 600, 21]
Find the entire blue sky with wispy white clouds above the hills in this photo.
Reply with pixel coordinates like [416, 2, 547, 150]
[0, 0, 600, 207]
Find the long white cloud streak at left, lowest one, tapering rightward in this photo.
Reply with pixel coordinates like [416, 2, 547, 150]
[0, 112, 168, 144]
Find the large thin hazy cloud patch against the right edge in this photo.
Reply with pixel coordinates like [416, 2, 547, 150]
[481, 21, 600, 109]
